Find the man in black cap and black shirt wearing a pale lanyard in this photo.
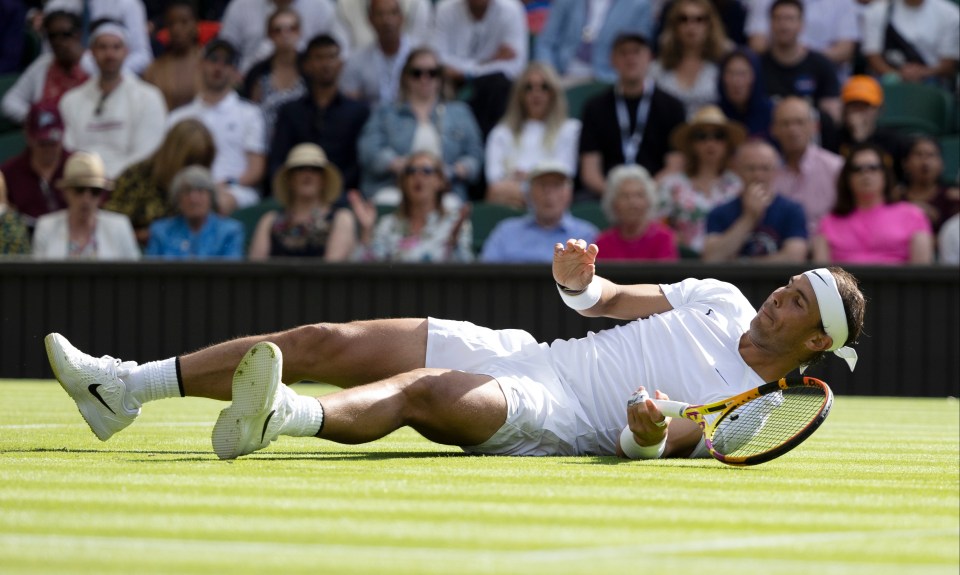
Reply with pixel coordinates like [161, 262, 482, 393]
[580, 33, 686, 199]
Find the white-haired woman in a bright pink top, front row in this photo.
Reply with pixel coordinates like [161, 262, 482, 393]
[595, 166, 679, 261]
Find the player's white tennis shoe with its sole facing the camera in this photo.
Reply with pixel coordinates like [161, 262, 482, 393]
[211, 342, 290, 459]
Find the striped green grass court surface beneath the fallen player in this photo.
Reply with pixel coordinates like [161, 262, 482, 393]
[0, 383, 960, 573]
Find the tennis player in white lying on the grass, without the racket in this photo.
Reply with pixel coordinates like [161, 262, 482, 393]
[46, 240, 865, 459]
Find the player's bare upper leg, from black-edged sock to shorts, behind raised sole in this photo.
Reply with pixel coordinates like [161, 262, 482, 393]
[180, 318, 427, 400]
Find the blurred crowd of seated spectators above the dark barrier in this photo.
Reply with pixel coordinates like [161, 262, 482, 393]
[0, 0, 960, 265]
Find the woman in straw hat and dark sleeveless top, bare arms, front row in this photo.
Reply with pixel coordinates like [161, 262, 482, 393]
[249, 143, 356, 262]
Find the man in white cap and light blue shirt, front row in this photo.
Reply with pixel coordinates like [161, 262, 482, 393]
[480, 160, 597, 263]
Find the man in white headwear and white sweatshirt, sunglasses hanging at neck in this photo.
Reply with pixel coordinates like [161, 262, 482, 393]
[59, 22, 167, 179]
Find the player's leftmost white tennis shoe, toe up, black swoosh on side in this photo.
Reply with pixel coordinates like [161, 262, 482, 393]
[43, 333, 140, 441]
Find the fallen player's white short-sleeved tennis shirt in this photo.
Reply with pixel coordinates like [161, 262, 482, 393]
[550, 279, 765, 453]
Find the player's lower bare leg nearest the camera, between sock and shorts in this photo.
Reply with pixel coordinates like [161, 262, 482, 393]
[318, 369, 507, 446]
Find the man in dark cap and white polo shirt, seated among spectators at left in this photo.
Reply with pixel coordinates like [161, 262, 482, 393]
[167, 39, 266, 214]
